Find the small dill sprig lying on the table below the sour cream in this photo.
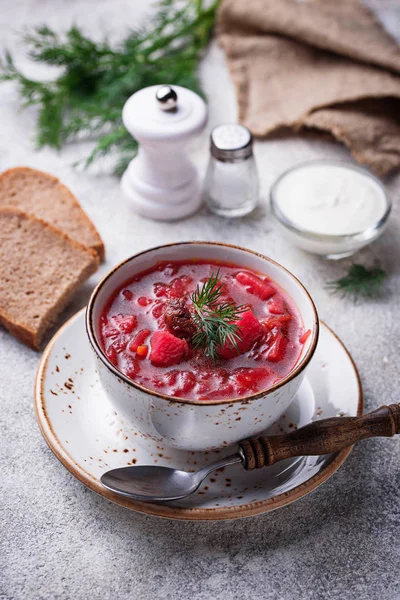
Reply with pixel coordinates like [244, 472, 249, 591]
[327, 264, 387, 298]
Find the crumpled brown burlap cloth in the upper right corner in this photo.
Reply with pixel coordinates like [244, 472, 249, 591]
[217, 0, 400, 175]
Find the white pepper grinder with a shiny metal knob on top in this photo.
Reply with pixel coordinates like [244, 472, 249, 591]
[121, 85, 207, 221]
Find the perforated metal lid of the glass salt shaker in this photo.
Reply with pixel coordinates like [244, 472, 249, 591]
[210, 123, 253, 162]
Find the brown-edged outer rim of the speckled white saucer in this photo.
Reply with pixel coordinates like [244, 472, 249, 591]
[34, 308, 364, 521]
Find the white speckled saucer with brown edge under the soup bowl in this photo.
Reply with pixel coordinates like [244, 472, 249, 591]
[35, 310, 363, 519]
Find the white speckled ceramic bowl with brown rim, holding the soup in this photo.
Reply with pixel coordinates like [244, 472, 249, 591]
[86, 242, 319, 450]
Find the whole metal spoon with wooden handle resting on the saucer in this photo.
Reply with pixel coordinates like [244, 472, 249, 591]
[100, 404, 400, 502]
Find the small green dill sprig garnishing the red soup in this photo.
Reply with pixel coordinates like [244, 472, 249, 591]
[191, 269, 246, 364]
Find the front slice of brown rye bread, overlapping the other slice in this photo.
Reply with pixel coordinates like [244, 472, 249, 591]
[0, 207, 99, 349]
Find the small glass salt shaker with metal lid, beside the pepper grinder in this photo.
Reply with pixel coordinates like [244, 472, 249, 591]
[204, 124, 258, 217]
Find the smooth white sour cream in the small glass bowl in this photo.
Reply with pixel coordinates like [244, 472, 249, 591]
[274, 163, 387, 235]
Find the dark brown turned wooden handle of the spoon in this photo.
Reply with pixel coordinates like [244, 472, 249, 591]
[239, 404, 400, 471]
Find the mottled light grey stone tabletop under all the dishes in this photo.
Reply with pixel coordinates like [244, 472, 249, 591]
[0, 0, 400, 600]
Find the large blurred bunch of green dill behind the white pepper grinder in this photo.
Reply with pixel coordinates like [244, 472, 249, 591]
[0, 0, 220, 174]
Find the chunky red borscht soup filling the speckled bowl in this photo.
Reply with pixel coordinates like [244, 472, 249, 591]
[100, 260, 310, 401]
